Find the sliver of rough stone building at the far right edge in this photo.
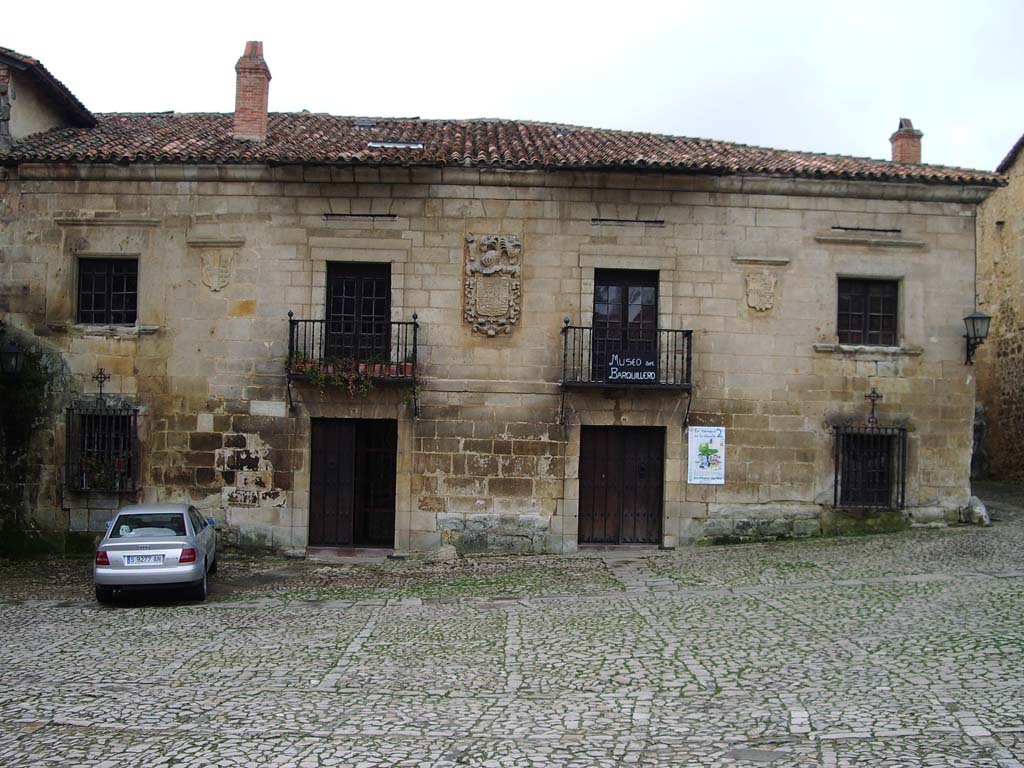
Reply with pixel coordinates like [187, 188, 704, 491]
[978, 136, 1024, 480]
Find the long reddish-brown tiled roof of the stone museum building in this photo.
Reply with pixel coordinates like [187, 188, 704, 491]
[2, 113, 1004, 186]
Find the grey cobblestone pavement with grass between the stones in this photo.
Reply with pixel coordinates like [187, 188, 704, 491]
[0, 485, 1024, 768]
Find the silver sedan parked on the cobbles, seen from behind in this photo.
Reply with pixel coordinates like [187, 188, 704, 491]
[92, 504, 217, 603]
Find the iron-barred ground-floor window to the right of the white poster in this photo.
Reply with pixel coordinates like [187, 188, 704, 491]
[834, 427, 906, 509]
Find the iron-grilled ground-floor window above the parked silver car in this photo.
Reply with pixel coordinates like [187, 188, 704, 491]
[65, 403, 138, 493]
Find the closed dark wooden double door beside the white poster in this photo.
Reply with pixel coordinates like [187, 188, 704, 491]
[579, 427, 665, 544]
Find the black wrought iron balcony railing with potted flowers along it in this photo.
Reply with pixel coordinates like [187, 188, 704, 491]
[288, 311, 419, 382]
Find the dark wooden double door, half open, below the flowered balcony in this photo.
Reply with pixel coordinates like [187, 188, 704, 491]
[309, 419, 398, 547]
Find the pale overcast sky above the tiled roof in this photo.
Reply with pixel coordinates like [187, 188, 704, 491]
[8, 0, 1024, 169]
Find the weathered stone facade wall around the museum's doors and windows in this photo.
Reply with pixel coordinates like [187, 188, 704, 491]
[0, 166, 980, 551]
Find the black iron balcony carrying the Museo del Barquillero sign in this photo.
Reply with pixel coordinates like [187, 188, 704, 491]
[562, 319, 693, 391]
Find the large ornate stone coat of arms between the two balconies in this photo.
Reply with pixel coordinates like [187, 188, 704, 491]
[465, 234, 522, 336]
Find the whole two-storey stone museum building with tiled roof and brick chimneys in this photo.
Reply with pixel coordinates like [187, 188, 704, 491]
[0, 43, 999, 552]
